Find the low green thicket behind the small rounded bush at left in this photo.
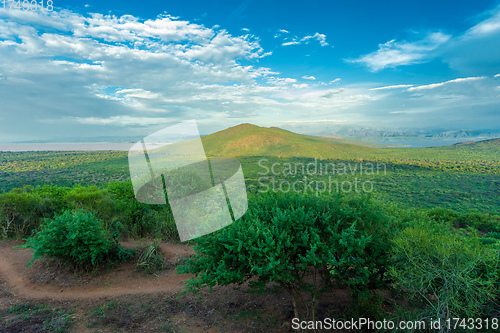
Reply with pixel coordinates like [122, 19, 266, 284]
[0, 181, 179, 240]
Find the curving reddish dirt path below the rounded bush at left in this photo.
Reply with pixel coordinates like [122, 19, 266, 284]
[0, 242, 193, 300]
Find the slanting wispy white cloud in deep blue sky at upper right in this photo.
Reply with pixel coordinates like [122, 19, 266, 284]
[347, 32, 451, 72]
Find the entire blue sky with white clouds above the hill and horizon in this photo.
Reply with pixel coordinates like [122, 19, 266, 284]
[0, 0, 500, 142]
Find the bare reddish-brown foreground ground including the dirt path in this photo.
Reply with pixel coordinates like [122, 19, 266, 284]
[0, 241, 364, 333]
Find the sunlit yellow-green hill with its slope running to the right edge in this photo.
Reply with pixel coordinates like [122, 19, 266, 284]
[202, 124, 500, 173]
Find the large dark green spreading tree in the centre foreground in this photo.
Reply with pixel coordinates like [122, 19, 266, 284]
[178, 195, 387, 320]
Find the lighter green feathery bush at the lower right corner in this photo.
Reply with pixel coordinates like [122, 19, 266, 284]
[390, 228, 499, 320]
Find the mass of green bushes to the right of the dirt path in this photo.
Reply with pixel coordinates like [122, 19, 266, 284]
[179, 195, 500, 331]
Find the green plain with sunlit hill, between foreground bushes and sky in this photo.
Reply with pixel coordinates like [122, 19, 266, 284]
[0, 124, 500, 212]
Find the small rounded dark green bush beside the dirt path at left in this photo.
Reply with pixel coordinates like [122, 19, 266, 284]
[26, 210, 133, 270]
